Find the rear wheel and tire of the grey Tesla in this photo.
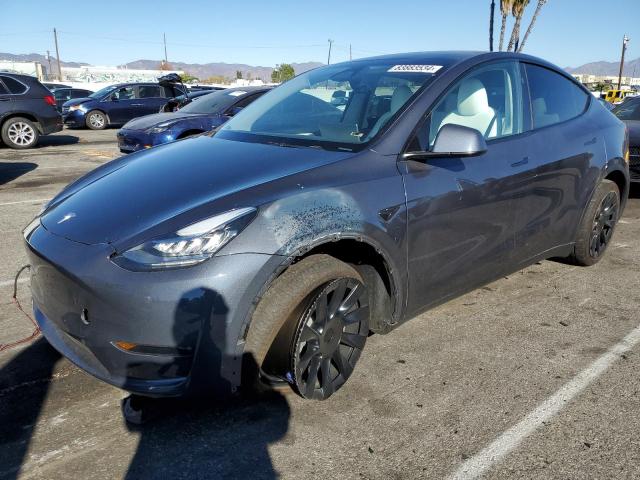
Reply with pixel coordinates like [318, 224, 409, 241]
[572, 180, 620, 267]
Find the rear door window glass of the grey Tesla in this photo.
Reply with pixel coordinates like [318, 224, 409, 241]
[525, 64, 589, 128]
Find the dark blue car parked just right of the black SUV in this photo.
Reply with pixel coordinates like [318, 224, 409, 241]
[62, 83, 184, 130]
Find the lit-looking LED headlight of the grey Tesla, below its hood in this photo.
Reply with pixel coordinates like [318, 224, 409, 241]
[112, 208, 256, 271]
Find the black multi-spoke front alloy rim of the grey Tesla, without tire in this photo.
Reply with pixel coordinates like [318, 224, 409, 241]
[291, 278, 369, 400]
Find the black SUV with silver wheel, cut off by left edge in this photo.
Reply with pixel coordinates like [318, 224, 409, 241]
[0, 72, 62, 149]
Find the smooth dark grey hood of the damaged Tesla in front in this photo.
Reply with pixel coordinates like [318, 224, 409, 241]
[41, 136, 353, 248]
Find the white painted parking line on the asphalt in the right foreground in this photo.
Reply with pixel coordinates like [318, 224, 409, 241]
[449, 325, 640, 480]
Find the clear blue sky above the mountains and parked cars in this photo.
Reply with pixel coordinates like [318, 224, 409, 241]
[0, 0, 640, 67]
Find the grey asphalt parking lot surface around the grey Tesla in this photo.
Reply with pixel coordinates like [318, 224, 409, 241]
[0, 129, 640, 479]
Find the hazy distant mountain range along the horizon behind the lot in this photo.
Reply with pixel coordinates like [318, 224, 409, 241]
[0, 52, 640, 80]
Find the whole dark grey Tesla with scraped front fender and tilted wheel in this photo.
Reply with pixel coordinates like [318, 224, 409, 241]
[24, 52, 629, 410]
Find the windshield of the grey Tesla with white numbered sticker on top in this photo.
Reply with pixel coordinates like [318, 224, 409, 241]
[219, 59, 440, 150]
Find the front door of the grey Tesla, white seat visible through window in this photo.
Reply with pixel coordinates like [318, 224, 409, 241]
[399, 61, 531, 314]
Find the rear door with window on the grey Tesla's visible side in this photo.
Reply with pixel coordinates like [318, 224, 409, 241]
[508, 63, 604, 264]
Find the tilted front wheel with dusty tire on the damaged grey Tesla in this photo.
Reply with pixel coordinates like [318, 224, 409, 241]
[243, 255, 370, 400]
